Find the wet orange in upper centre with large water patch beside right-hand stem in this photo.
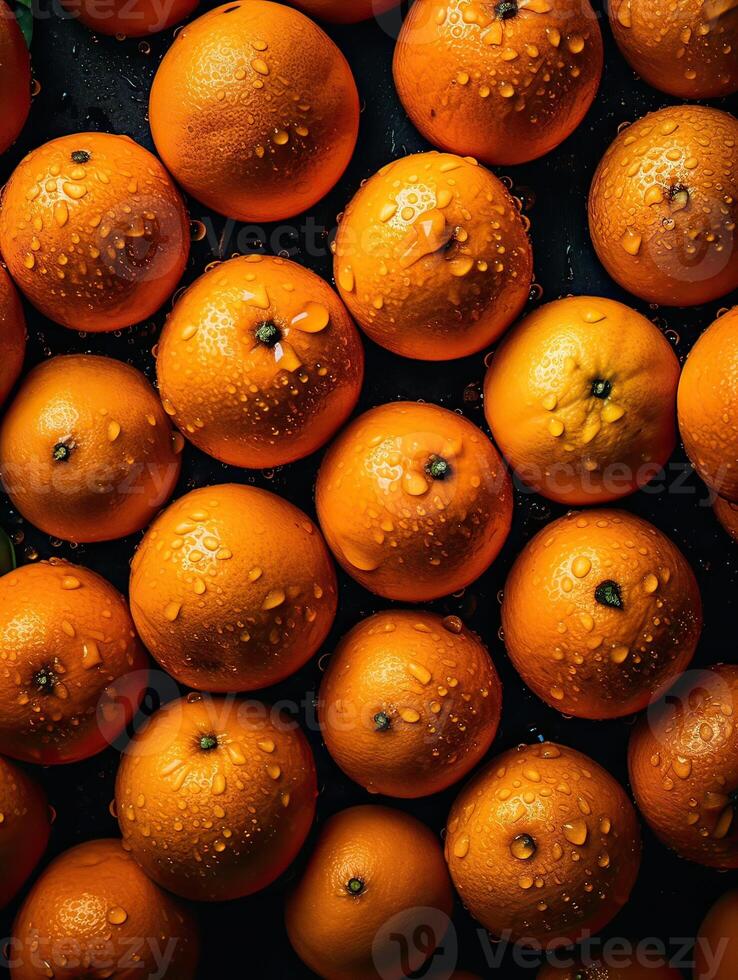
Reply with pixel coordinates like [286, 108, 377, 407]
[333, 152, 533, 361]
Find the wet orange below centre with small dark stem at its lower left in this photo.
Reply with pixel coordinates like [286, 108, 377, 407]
[319, 610, 502, 798]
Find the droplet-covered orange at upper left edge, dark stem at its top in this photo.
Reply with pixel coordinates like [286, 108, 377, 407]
[0, 133, 190, 333]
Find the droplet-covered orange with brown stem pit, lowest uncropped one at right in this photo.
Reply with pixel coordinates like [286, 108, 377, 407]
[446, 742, 641, 948]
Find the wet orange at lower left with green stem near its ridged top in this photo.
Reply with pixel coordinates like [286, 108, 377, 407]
[115, 694, 318, 902]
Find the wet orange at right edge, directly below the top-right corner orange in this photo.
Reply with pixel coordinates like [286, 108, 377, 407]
[589, 105, 738, 306]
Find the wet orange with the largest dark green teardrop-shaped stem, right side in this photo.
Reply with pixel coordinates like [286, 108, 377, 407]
[502, 510, 702, 718]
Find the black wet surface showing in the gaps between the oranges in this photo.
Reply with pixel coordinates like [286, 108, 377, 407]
[0, 0, 738, 978]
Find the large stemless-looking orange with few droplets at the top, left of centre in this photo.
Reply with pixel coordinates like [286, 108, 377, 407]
[149, 0, 359, 221]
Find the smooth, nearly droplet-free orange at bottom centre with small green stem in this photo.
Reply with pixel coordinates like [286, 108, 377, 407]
[285, 806, 453, 980]
